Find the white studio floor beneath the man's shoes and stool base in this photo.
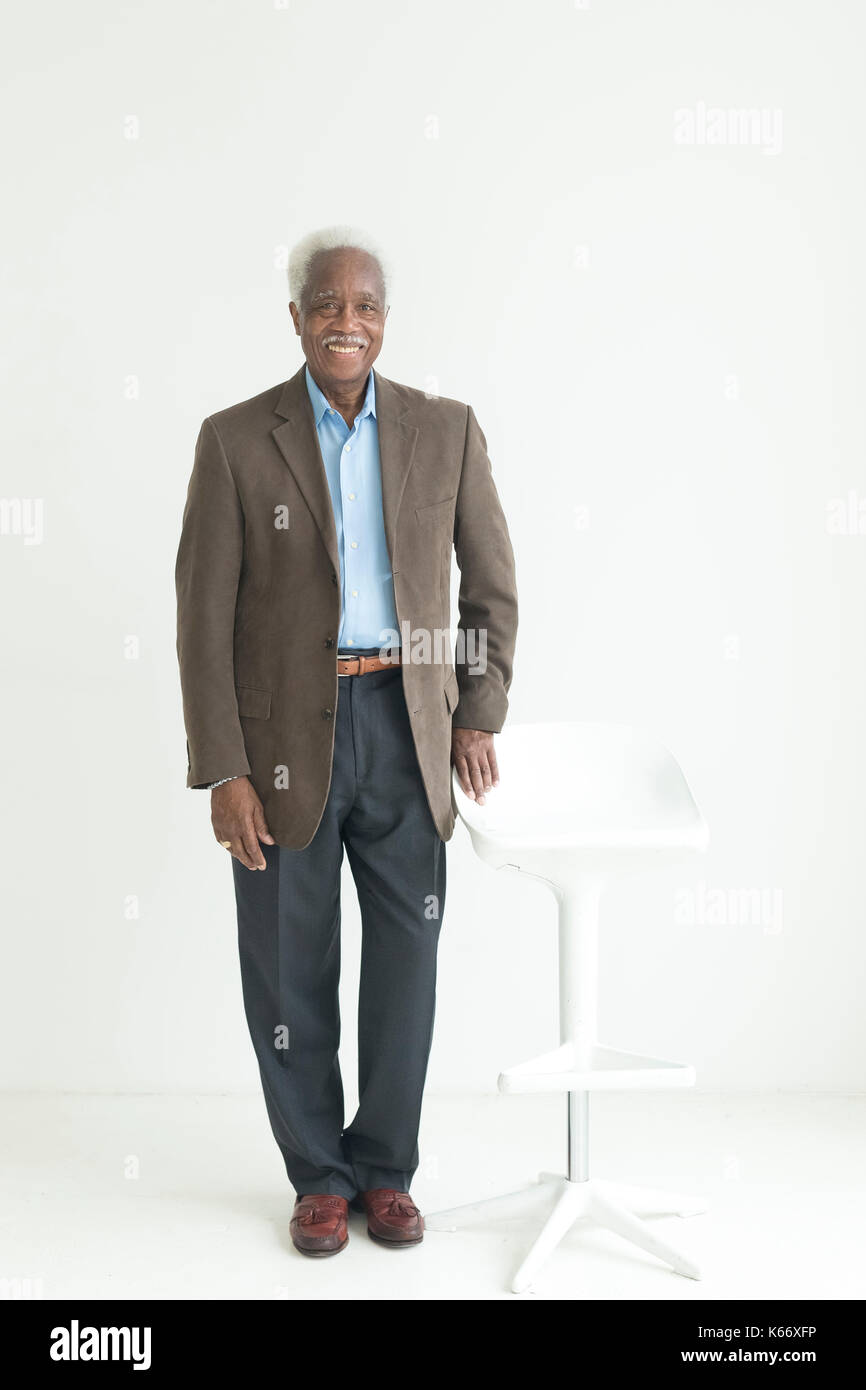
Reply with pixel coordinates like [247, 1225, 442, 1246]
[0, 1091, 866, 1301]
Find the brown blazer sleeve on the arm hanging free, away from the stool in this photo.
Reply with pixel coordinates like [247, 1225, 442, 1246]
[175, 418, 250, 787]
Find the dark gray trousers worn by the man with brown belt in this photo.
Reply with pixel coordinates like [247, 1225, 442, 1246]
[232, 653, 446, 1198]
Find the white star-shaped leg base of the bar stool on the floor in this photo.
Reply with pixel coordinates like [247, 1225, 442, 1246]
[424, 1173, 706, 1294]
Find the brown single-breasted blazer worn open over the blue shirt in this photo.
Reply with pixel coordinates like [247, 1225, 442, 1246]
[175, 366, 517, 849]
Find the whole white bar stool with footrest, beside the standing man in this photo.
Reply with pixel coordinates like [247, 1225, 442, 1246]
[425, 723, 709, 1293]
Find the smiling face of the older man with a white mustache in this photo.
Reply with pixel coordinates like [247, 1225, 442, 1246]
[289, 249, 388, 393]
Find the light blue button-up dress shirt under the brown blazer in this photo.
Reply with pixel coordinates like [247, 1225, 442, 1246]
[306, 367, 399, 648]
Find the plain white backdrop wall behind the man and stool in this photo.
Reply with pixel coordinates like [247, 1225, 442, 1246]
[0, 0, 866, 1099]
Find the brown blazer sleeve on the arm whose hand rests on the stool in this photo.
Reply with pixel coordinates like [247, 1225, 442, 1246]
[452, 406, 517, 734]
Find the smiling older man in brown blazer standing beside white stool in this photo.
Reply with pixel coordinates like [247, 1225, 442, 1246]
[177, 227, 517, 1255]
